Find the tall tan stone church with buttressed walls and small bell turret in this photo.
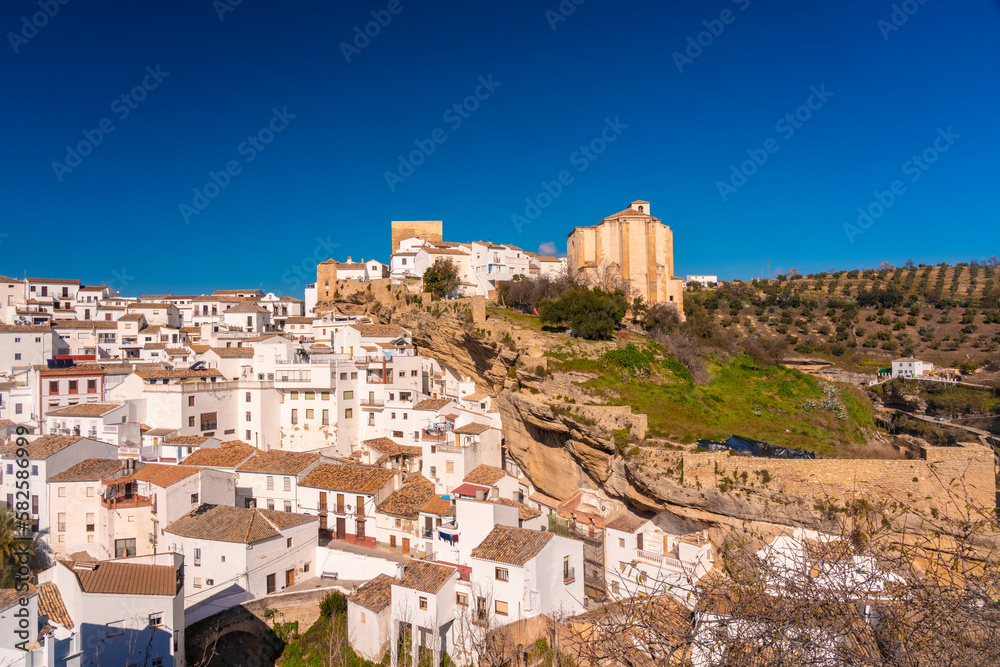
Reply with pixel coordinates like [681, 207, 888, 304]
[566, 200, 684, 316]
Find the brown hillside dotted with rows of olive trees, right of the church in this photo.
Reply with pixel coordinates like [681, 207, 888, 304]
[685, 263, 1000, 381]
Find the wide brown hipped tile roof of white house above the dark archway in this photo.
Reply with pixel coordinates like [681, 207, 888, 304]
[166, 505, 319, 544]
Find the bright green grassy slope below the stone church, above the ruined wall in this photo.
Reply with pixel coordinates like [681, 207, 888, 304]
[550, 344, 874, 456]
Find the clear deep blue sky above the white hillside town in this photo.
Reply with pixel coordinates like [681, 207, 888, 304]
[0, 0, 1000, 296]
